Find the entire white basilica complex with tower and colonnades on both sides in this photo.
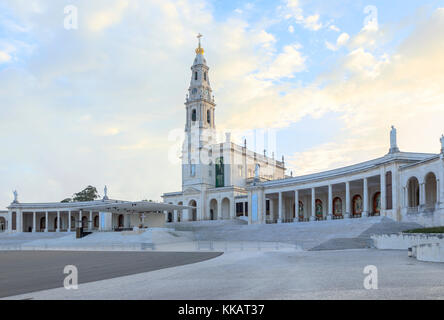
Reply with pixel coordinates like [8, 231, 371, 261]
[0, 36, 444, 232]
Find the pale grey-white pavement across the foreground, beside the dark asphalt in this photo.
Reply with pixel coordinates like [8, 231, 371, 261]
[6, 249, 444, 300]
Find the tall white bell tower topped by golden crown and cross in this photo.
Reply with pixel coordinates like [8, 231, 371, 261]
[182, 34, 216, 190]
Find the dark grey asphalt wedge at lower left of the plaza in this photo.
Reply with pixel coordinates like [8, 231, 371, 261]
[0, 251, 222, 298]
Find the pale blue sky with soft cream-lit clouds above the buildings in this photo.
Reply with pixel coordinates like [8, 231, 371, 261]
[0, 0, 444, 210]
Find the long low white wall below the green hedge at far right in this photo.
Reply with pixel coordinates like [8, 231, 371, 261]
[371, 233, 444, 250]
